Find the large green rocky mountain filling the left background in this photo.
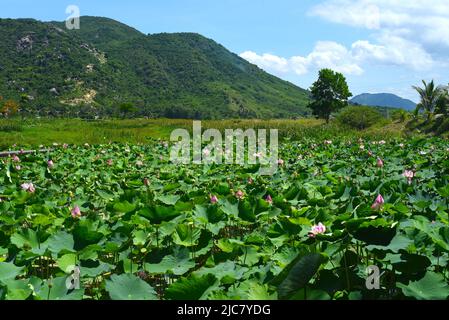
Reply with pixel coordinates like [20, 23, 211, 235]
[0, 16, 309, 118]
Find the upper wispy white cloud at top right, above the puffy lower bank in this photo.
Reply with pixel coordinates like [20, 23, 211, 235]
[309, 0, 449, 49]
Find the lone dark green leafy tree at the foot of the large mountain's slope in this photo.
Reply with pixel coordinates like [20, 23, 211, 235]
[309, 69, 352, 123]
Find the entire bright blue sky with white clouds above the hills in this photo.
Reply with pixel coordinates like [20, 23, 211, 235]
[0, 0, 449, 101]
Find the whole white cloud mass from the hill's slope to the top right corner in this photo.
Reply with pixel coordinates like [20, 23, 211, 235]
[241, 0, 442, 75]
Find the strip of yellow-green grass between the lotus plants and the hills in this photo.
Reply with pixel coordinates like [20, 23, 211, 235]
[0, 119, 404, 149]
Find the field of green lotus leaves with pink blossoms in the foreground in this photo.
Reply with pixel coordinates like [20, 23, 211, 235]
[0, 138, 449, 300]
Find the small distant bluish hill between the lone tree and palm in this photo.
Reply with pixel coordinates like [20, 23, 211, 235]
[350, 93, 416, 111]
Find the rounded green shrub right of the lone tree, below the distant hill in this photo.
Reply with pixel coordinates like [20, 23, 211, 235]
[337, 106, 383, 130]
